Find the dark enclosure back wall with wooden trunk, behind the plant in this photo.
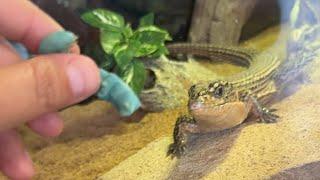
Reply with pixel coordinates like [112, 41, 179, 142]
[33, 0, 282, 45]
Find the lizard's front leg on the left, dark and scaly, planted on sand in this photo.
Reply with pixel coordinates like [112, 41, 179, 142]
[168, 116, 198, 157]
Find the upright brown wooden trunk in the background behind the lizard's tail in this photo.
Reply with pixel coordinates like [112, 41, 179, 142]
[189, 0, 257, 45]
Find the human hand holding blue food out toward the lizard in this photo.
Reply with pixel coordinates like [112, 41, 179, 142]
[0, 0, 100, 179]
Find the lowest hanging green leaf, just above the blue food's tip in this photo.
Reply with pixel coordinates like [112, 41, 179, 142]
[120, 60, 147, 94]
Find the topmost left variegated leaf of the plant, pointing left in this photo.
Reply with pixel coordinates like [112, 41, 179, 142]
[81, 9, 125, 31]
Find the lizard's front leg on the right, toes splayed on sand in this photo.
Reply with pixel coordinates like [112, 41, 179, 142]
[250, 97, 279, 123]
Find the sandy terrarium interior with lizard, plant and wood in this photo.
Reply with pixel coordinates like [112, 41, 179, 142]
[5, 0, 320, 179]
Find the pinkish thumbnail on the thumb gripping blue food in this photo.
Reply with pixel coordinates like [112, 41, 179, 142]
[67, 56, 100, 98]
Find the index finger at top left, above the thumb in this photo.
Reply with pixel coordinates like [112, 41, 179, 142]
[0, 0, 62, 52]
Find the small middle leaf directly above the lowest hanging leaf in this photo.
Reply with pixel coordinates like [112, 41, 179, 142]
[114, 44, 134, 69]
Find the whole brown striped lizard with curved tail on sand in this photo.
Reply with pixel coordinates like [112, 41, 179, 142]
[168, 43, 280, 157]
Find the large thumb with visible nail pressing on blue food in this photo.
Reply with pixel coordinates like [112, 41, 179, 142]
[0, 54, 100, 131]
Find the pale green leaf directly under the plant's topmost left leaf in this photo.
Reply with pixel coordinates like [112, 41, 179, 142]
[100, 30, 123, 54]
